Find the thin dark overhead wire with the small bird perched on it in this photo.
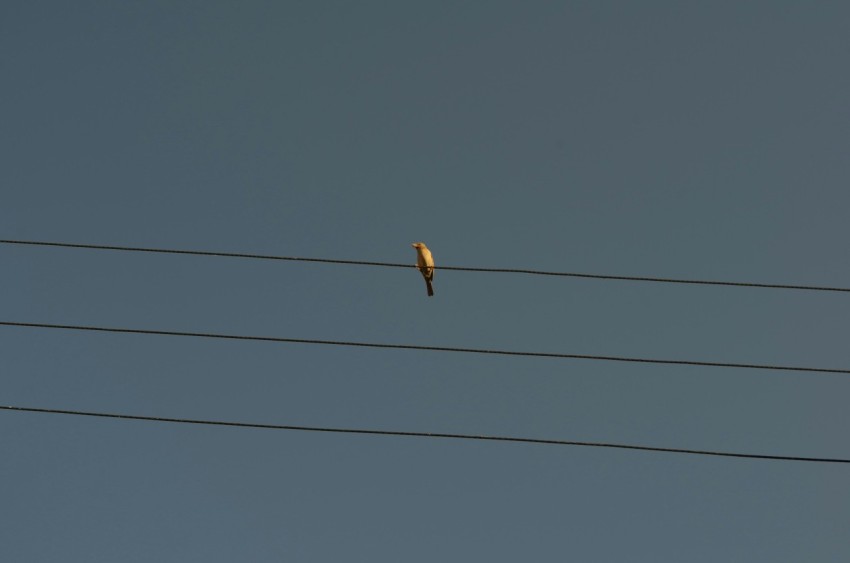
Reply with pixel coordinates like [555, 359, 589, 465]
[0, 240, 850, 293]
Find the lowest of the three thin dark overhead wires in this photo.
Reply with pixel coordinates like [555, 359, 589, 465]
[0, 405, 850, 463]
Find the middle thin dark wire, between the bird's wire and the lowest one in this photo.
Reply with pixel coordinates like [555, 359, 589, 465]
[0, 321, 850, 374]
